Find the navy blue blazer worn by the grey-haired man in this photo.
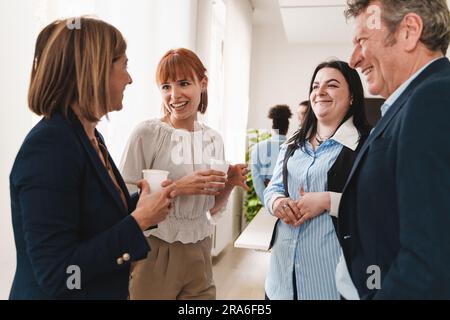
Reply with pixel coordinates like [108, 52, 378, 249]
[338, 58, 450, 299]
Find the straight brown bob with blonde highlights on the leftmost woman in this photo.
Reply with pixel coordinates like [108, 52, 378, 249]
[28, 17, 126, 122]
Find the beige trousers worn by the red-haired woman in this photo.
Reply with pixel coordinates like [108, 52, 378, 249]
[130, 236, 216, 300]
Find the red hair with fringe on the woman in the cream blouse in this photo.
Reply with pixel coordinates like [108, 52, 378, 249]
[156, 48, 208, 114]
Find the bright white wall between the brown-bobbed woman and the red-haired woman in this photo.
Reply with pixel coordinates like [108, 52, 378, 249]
[93, 0, 197, 164]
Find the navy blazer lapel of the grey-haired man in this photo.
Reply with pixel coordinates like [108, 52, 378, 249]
[343, 58, 449, 192]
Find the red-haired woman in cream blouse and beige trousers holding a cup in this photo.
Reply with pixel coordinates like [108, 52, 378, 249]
[121, 48, 247, 300]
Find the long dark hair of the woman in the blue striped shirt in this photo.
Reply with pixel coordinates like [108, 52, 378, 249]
[289, 60, 370, 149]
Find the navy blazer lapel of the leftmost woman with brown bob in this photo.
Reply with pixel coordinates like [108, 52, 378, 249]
[69, 110, 130, 214]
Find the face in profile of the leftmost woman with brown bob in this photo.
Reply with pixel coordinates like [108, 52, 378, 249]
[109, 54, 133, 111]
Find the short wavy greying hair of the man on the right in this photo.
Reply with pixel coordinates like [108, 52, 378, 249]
[345, 0, 450, 55]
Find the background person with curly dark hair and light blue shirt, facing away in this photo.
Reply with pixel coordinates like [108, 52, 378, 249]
[250, 104, 292, 203]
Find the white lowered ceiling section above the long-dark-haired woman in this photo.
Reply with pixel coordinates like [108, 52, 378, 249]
[250, 0, 450, 44]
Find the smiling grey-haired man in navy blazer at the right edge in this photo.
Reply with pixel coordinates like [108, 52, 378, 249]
[336, 0, 450, 299]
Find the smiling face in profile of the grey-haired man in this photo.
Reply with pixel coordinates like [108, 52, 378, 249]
[349, 5, 406, 98]
